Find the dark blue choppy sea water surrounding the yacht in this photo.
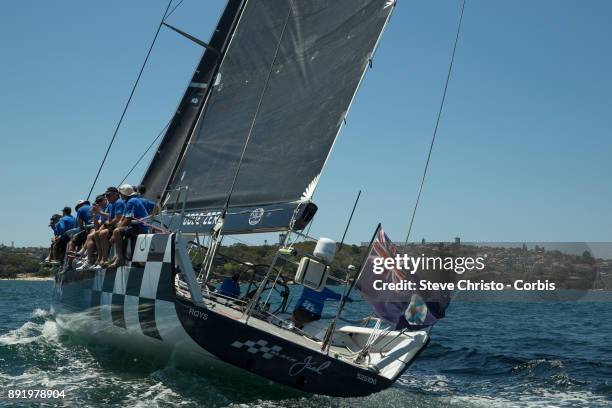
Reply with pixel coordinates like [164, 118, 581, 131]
[0, 281, 612, 408]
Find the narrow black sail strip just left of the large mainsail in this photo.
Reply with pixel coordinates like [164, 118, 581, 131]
[142, 0, 246, 200]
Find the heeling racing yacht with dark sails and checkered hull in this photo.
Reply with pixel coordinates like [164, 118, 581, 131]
[53, 0, 444, 397]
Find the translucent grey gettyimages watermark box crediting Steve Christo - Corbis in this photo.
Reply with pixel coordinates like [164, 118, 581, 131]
[363, 239, 612, 302]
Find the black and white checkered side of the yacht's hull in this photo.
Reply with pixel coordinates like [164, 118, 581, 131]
[54, 234, 215, 362]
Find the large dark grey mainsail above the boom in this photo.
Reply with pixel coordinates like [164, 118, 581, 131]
[153, 0, 395, 233]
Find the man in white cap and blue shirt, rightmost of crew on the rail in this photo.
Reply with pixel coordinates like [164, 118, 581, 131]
[108, 184, 149, 268]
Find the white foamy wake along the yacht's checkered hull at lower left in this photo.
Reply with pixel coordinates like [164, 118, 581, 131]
[0, 309, 296, 407]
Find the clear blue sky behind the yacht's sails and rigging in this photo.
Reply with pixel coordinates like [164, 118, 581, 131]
[0, 0, 612, 246]
